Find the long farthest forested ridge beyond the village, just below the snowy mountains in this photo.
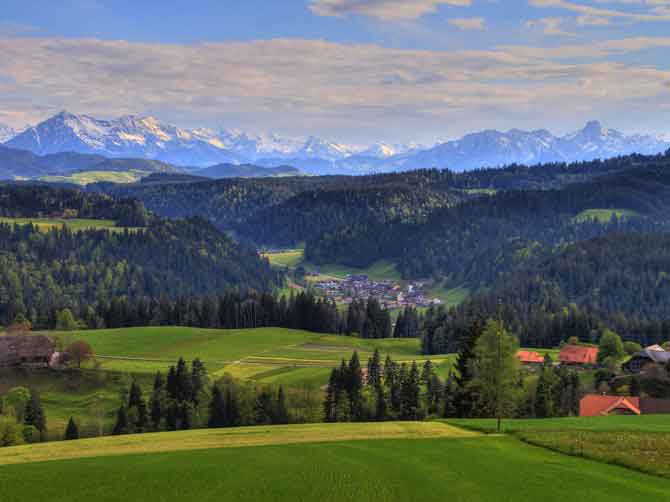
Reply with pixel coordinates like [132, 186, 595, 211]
[88, 155, 664, 246]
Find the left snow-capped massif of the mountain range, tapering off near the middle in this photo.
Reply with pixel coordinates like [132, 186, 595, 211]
[6, 112, 356, 166]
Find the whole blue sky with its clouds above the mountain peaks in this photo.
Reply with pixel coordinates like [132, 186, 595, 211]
[0, 0, 670, 144]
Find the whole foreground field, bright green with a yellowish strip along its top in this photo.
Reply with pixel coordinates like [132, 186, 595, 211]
[0, 424, 670, 502]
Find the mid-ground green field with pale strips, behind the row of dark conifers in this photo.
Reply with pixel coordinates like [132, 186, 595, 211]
[48, 327, 453, 385]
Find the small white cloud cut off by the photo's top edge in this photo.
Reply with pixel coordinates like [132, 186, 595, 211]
[309, 0, 472, 21]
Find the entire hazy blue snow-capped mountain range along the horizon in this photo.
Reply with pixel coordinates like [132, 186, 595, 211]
[0, 112, 670, 174]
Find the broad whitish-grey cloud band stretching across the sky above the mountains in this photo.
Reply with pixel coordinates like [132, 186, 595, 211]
[0, 38, 670, 141]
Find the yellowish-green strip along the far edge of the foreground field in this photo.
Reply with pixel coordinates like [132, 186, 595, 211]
[0, 422, 479, 465]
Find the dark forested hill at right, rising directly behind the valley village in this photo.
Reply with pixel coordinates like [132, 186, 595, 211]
[305, 157, 670, 282]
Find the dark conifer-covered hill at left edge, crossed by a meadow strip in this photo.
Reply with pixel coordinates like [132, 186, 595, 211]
[0, 187, 279, 328]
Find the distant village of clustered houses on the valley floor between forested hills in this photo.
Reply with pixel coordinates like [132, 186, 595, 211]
[312, 272, 442, 310]
